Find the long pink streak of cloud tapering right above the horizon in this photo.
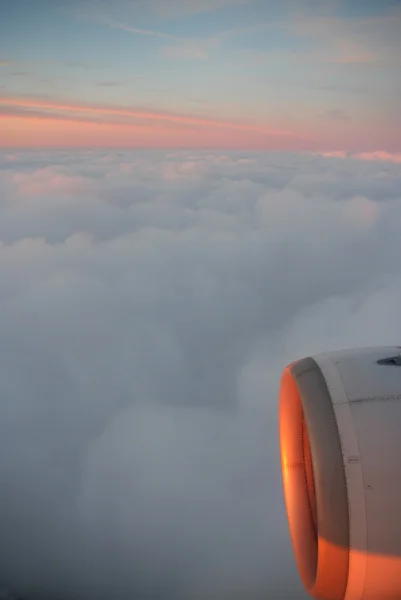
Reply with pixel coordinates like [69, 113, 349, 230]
[0, 96, 311, 148]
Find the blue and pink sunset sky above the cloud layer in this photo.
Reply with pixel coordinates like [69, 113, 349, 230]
[0, 0, 401, 153]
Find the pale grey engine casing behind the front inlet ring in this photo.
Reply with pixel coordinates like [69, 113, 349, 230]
[314, 346, 401, 600]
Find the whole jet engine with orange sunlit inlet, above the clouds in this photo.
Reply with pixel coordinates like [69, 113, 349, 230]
[279, 346, 401, 600]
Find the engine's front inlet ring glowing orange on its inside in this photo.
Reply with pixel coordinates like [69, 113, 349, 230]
[279, 358, 349, 600]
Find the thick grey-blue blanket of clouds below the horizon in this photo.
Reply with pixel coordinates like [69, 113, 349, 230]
[0, 146, 401, 600]
